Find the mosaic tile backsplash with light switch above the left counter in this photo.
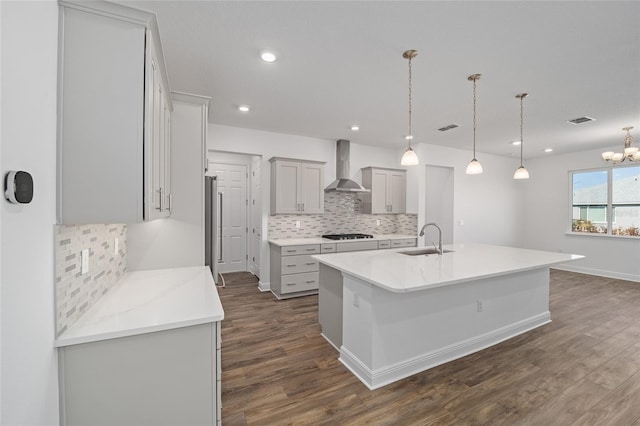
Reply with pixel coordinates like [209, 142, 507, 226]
[55, 225, 127, 336]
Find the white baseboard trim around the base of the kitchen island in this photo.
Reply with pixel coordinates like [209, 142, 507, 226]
[338, 311, 551, 390]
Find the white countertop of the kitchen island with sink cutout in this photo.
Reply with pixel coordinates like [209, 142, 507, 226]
[312, 243, 584, 293]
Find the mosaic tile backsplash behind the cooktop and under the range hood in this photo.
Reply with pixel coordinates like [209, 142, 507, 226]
[269, 192, 418, 238]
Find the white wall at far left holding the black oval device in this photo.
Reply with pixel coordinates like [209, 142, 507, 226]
[0, 1, 59, 425]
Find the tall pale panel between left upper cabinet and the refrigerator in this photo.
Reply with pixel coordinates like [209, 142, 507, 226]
[127, 95, 208, 271]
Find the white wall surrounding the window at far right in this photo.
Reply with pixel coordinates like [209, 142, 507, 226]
[522, 146, 640, 281]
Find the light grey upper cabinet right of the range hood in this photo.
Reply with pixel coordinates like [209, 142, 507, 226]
[362, 167, 407, 214]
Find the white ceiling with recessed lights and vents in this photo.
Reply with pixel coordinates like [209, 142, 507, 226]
[120, 1, 640, 157]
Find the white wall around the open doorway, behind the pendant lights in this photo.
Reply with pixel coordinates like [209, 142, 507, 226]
[407, 144, 536, 247]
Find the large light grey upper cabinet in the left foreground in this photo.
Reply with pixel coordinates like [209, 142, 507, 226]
[58, 1, 172, 224]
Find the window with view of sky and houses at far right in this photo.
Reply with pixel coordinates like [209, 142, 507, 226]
[571, 166, 640, 237]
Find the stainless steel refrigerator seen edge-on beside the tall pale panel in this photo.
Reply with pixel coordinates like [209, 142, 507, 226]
[209, 176, 222, 285]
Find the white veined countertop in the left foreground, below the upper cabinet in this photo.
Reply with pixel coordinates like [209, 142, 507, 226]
[55, 266, 224, 347]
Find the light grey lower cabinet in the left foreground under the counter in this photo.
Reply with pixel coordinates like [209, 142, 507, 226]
[58, 322, 221, 426]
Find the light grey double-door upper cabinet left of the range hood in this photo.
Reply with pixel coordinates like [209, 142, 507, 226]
[269, 157, 324, 215]
